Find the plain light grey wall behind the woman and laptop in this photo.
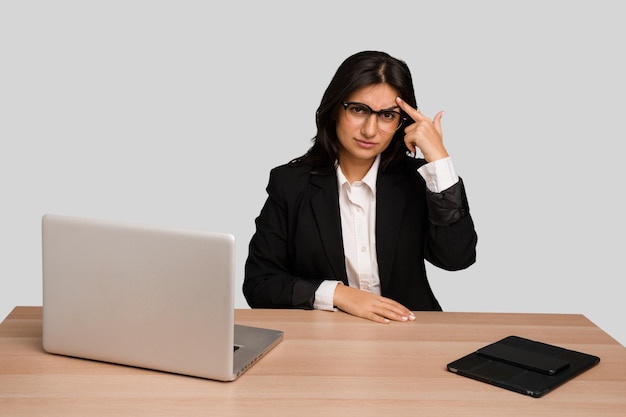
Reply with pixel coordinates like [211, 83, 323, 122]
[0, 0, 626, 344]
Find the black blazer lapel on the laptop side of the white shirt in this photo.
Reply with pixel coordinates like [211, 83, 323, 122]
[311, 175, 348, 285]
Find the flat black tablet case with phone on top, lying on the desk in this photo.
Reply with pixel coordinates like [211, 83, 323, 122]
[447, 336, 600, 398]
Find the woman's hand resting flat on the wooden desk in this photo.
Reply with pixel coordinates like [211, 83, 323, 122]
[333, 283, 415, 323]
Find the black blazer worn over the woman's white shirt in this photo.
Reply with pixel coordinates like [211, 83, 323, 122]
[243, 157, 477, 310]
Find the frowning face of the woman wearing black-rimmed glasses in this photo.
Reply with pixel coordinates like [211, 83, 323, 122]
[336, 84, 400, 165]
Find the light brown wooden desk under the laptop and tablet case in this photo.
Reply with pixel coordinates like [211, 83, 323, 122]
[0, 307, 626, 417]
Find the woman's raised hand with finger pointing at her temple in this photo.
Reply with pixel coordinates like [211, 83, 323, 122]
[396, 97, 448, 162]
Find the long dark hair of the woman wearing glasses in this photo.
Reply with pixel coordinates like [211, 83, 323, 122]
[293, 51, 417, 170]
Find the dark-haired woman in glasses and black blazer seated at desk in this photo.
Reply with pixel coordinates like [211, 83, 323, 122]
[243, 51, 477, 323]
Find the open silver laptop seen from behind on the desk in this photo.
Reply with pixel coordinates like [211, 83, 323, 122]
[42, 214, 283, 381]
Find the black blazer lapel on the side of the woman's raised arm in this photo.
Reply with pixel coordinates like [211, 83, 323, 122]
[376, 167, 407, 287]
